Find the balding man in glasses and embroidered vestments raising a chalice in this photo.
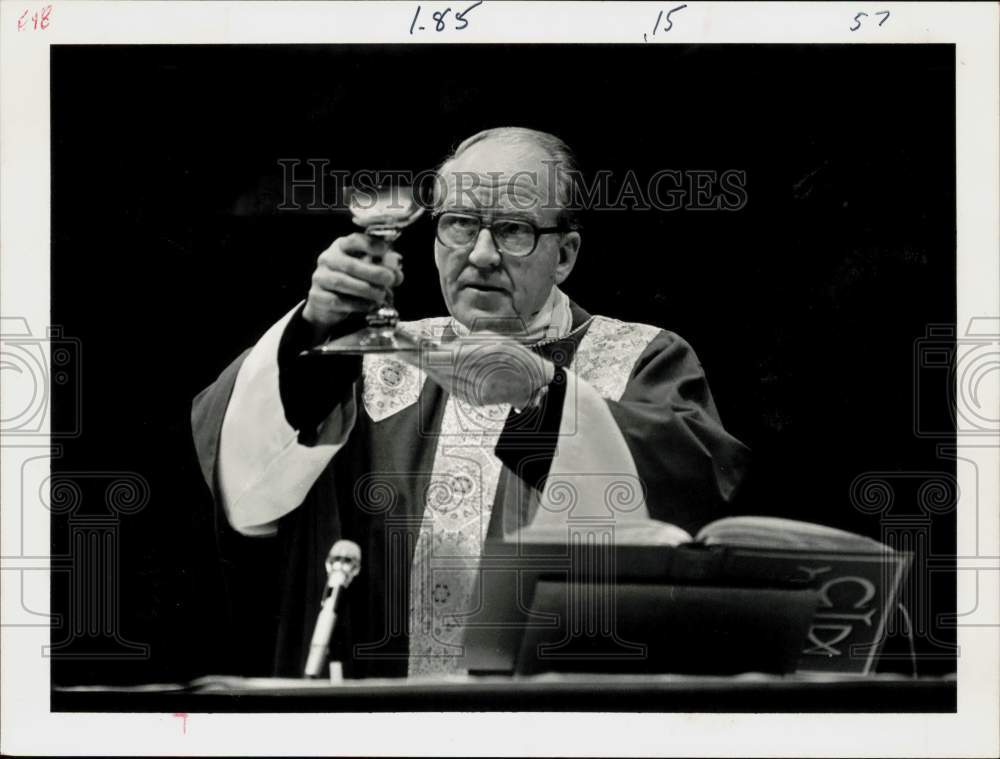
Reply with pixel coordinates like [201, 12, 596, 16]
[193, 128, 746, 676]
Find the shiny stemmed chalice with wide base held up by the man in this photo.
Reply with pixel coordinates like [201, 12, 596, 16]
[305, 186, 424, 356]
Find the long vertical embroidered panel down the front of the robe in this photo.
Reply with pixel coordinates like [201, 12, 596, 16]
[409, 397, 510, 676]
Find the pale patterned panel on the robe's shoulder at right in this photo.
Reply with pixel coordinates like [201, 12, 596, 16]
[570, 316, 661, 401]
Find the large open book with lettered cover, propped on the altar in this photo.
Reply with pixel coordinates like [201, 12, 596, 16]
[507, 516, 912, 674]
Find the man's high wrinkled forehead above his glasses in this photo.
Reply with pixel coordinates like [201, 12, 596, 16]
[442, 142, 557, 212]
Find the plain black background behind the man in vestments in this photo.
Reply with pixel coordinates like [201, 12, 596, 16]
[51, 45, 955, 684]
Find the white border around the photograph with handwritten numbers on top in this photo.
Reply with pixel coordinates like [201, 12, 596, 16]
[0, 0, 1000, 756]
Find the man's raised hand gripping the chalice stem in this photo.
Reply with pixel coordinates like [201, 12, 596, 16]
[302, 232, 403, 343]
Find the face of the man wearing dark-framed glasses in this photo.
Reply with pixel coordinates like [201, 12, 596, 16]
[434, 140, 580, 332]
